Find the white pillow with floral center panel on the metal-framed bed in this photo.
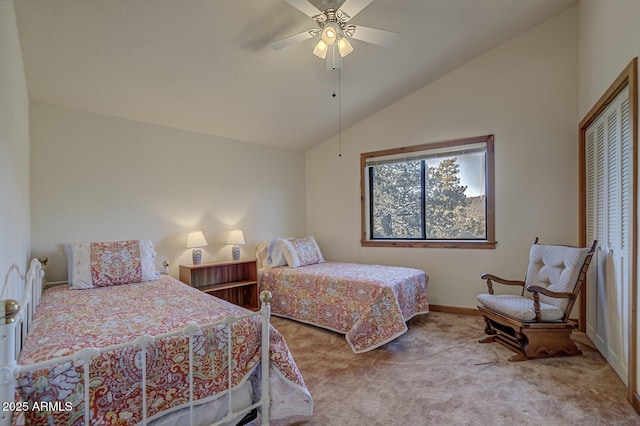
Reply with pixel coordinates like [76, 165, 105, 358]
[65, 240, 160, 289]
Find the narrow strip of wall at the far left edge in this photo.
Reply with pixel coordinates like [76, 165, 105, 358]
[0, 1, 30, 299]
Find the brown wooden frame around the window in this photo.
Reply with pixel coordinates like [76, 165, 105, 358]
[360, 135, 497, 249]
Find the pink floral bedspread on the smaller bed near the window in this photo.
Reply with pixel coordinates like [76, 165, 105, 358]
[260, 262, 429, 353]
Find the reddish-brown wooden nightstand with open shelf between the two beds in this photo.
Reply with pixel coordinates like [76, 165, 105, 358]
[180, 259, 260, 311]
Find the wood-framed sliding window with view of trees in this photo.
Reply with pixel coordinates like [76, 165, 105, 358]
[360, 135, 495, 248]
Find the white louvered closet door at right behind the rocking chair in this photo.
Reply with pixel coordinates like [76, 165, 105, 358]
[585, 89, 633, 384]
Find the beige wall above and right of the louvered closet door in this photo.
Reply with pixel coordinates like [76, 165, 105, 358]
[578, 0, 640, 406]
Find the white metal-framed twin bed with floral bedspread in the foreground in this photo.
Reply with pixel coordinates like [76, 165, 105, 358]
[0, 241, 313, 426]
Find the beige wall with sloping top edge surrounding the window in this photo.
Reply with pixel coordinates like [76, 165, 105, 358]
[306, 8, 578, 307]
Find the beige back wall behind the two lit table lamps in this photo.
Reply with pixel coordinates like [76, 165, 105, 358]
[30, 102, 305, 280]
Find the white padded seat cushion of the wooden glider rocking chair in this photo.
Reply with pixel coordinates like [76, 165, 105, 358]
[477, 294, 563, 322]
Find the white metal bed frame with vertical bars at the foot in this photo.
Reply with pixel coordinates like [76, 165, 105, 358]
[0, 259, 271, 426]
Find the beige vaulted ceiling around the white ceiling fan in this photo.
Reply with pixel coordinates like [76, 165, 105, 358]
[15, 0, 577, 150]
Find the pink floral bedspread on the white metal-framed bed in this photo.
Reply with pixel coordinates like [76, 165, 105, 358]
[18, 276, 312, 425]
